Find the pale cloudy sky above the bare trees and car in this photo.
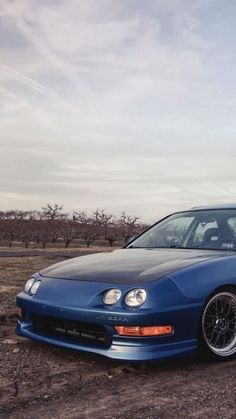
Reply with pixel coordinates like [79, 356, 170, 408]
[0, 0, 236, 222]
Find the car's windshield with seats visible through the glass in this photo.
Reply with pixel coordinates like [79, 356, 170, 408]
[127, 210, 236, 250]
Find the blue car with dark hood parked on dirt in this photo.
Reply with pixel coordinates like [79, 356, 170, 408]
[16, 205, 236, 361]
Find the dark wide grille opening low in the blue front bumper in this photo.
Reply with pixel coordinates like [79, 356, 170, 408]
[32, 314, 111, 346]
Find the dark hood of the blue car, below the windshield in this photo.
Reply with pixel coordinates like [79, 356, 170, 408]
[40, 248, 232, 284]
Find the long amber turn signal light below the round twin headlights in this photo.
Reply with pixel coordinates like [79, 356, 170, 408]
[115, 325, 174, 336]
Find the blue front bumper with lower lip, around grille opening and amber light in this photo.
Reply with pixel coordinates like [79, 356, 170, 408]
[16, 293, 202, 361]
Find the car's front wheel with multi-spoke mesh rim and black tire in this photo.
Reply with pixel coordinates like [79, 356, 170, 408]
[199, 287, 236, 361]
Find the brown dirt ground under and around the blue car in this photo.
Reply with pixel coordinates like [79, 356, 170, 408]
[0, 256, 236, 419]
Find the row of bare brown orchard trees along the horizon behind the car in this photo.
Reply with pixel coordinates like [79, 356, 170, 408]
[0, 207, 142, 248]
